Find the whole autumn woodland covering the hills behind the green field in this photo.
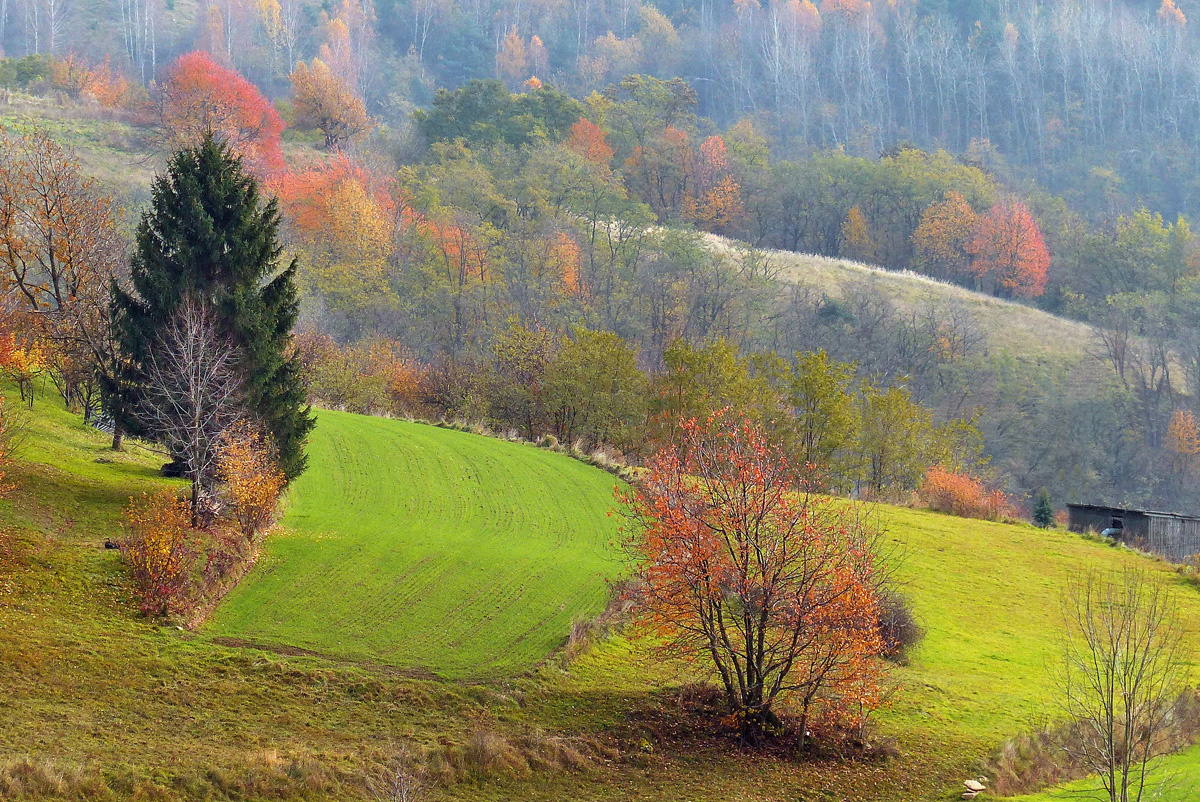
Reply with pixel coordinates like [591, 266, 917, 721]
[0, 0, 1200, 510]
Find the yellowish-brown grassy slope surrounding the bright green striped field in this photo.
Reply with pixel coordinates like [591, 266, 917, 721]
[7, 386, 1200, 802]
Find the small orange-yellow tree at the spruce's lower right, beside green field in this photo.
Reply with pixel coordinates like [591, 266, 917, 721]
[217, 421, 284, 540]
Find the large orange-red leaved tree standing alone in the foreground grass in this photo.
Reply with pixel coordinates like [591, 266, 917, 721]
[623, 412, 883, 743]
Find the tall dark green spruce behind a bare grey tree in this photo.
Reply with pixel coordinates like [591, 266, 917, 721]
[113, 134, 314, 479]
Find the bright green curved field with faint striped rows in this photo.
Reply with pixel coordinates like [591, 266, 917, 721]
[204, 412, 620, 678]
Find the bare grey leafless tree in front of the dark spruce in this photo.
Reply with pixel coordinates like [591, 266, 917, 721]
[142, 298, 241, 526]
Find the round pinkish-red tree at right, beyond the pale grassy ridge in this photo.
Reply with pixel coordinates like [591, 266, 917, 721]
[967, 199, 1050, 298]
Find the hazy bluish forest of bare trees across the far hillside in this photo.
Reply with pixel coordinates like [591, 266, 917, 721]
[0, 0, 1200, 219]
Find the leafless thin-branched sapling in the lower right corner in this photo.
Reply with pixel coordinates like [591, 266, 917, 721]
[1055, 568, 1183, 802]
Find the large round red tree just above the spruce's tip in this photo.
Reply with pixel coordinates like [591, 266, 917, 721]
[155, 50, 283, 173]
